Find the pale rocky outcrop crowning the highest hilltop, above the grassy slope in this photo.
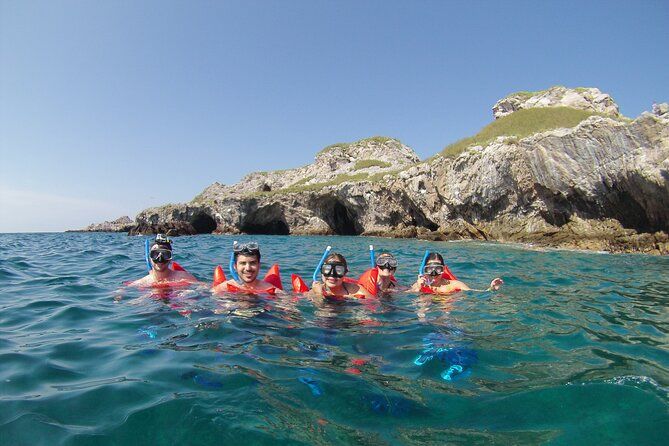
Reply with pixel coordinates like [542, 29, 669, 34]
[492, 86, 620, 119]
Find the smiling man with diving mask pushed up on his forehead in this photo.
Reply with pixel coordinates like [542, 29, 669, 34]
[212, 242, 282, 294]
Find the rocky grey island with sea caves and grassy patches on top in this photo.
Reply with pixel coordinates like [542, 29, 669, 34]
[85, 87, 669, 254]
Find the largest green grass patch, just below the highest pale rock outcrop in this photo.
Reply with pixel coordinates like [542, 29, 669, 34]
[440, 106, 615, 157]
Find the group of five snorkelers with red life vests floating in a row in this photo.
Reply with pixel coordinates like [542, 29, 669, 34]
[129, 234, 503, 298]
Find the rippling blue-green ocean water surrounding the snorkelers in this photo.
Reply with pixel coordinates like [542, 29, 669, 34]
[0, 234, 669, 446]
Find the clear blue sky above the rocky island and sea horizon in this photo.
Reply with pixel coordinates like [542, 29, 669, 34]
[0, 0, 669, 232]
